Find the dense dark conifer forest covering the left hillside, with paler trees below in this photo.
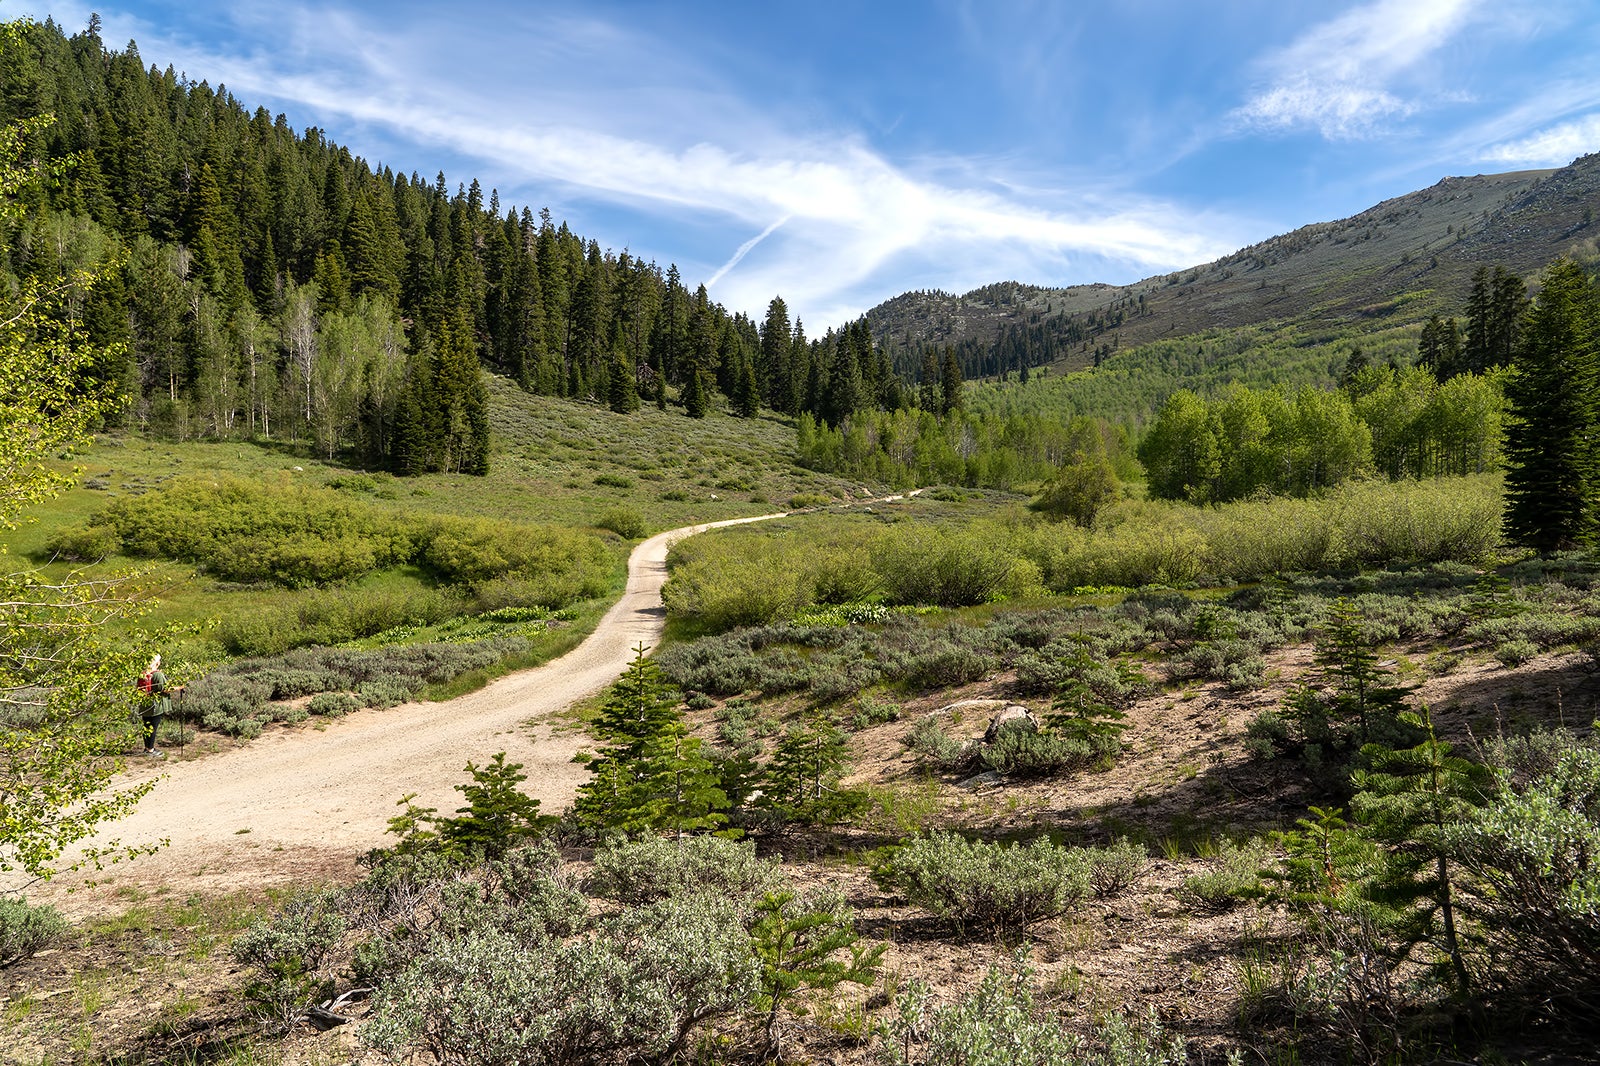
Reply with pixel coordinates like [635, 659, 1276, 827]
[0, 18, 928, 472]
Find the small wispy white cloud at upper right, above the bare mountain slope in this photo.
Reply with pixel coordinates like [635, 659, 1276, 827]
[1234, 0, 1482, 139]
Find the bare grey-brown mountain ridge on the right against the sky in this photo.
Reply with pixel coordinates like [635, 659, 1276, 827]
[866, 154, 1600, 376]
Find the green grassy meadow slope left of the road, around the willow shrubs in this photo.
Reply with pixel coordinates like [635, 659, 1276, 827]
[0, 385, 883, 698]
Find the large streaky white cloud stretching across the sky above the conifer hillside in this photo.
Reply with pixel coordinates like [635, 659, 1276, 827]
[78, 8, 1240, 325]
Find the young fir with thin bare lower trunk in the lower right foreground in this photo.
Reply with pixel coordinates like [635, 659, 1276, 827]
[1354, 706, 1488, 999]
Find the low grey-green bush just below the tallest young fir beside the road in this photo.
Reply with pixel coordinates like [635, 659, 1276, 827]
[587, 836, 784, 906]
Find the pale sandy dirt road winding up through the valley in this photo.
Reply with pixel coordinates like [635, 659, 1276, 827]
[29, 514, 800, 912]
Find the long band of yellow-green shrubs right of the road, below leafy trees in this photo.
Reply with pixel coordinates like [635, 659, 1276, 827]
[664, 475, 1501, 630]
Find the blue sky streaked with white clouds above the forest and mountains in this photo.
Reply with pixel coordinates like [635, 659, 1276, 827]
[12, 0, 1600, 327]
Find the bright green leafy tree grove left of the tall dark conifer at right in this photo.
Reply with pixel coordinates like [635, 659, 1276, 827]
[1139, 367, 1504, 503]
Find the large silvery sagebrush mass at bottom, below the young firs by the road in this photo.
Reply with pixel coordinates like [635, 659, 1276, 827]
[232, 806, 883, 1063]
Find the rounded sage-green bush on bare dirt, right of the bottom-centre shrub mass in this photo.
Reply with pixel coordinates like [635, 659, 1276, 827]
[878, 832, 1090, 940]
